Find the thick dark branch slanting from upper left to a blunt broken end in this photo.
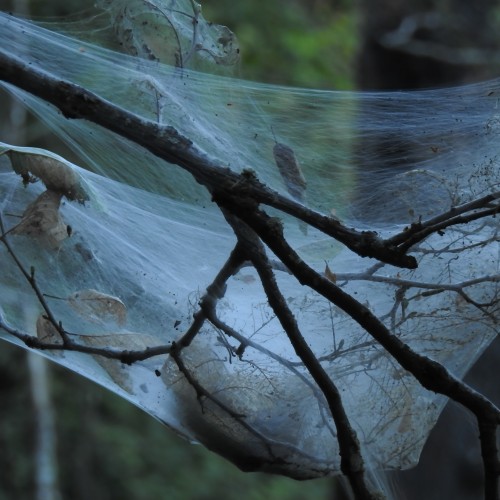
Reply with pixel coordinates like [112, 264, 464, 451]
[0, 50, 417, 269]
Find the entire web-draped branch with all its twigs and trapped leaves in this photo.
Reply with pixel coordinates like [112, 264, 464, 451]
[0, 6, 500, 499]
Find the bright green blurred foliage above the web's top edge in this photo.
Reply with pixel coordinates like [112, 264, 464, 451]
[203, 0, 358, 89]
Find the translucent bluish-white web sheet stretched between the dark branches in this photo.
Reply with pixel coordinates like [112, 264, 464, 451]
[0, 4, 500, 478]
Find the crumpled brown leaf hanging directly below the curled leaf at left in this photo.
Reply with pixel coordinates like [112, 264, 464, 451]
[11, 191, 69, 248]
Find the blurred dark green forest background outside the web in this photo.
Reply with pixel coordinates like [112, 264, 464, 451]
[0, 0, 500, 500]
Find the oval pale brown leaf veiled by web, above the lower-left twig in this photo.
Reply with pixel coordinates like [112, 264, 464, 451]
[68, 289, 127, 325]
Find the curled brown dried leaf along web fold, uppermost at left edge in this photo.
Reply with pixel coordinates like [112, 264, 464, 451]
[7, 149, 89, 203]
